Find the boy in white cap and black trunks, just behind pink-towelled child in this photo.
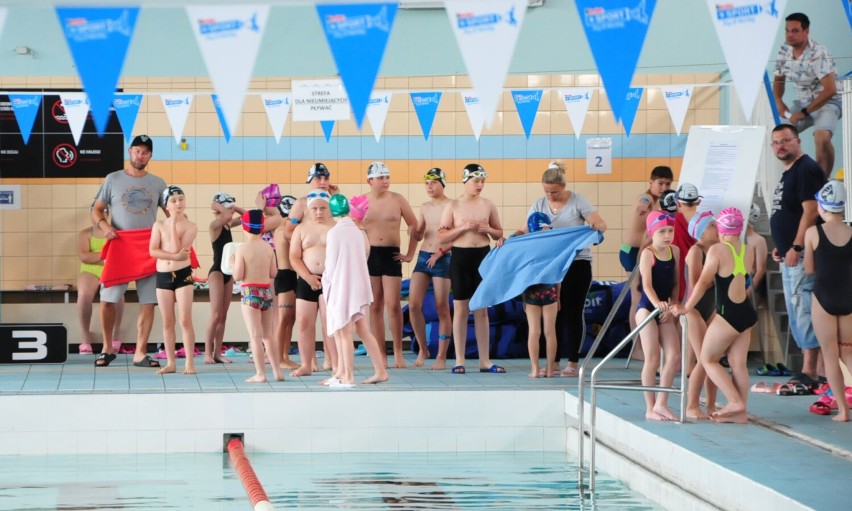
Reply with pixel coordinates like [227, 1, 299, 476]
[364, 161, 420, 368]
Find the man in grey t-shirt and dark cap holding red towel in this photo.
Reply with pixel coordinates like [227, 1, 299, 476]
[91, 135, 166, 367]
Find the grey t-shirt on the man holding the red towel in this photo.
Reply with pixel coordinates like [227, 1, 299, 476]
[95, 170, 166, 231]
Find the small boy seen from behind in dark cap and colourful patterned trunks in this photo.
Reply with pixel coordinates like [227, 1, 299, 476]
[234, 209, 284, 383]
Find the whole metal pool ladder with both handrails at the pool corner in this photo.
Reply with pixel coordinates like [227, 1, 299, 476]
[577, 264, 688, 498]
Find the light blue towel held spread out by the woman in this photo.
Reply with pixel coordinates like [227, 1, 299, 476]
[470, 226, 603, 311]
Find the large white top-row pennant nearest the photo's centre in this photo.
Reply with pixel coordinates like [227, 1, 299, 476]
[444, 0, 528, 127]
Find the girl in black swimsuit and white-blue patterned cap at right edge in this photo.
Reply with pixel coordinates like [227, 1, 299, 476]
[804, 181, 852, 422]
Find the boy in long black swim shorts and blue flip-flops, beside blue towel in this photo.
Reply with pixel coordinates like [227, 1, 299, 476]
[438, 163, 506, 374]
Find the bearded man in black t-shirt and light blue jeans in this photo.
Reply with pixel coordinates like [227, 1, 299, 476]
[769, 124, 825, 379]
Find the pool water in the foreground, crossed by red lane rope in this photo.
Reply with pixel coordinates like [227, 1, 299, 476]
[0, 452, 662, 511]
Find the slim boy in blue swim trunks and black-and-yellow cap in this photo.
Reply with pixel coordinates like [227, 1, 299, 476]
[408, 168, 453, 370]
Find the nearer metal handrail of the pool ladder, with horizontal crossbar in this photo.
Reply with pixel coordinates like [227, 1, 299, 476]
[577, 309, 688, 495]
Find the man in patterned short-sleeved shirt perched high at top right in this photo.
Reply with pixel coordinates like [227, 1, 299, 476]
[772, 12, 841, 177]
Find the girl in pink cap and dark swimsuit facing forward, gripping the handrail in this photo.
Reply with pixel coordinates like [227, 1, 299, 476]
[635, 211, 680, 421]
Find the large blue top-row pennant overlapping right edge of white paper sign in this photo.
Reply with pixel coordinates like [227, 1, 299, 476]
[316, 2, 397, 129]
